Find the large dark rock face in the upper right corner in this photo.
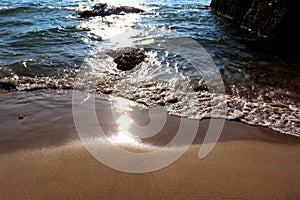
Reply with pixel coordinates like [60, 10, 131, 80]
[210, 0, 300, 49]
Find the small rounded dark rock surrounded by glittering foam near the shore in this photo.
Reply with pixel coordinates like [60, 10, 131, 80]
[114, 49, 146, 71]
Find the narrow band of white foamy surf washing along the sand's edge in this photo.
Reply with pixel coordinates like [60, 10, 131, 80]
[0, 75, 300, 137]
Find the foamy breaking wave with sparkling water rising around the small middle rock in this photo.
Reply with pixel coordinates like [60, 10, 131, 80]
[0, 44, 300, 136]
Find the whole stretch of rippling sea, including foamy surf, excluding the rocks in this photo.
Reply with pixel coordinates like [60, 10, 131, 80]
[0, 0, 300, 135]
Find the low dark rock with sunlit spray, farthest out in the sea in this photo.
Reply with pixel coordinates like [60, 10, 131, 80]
[79, 3, 144, 18]
